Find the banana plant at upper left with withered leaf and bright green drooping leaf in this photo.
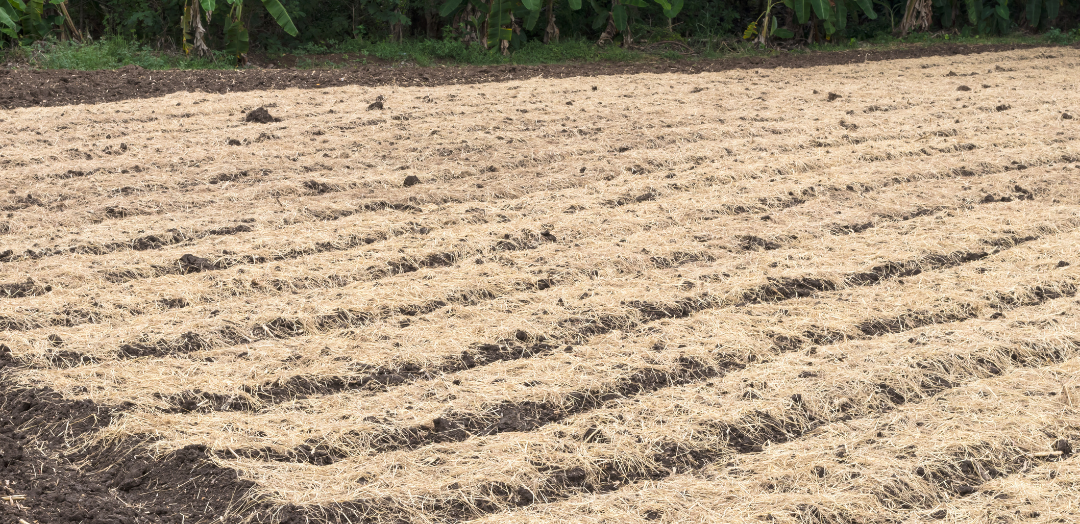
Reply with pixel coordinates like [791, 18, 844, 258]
[180, 0, 299, 65]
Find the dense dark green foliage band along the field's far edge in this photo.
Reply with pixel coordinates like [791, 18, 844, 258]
[0, 0, 1080, 55]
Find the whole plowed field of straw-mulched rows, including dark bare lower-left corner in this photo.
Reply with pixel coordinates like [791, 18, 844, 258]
[0, 48, 1080, 524]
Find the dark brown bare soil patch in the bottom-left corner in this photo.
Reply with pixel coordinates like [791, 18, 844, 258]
[0, 375, 261, 524]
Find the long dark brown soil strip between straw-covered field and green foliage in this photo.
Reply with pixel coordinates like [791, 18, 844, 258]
[0, 44, 1062, 109]
